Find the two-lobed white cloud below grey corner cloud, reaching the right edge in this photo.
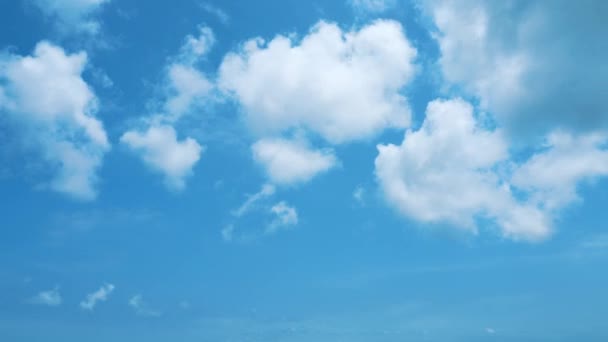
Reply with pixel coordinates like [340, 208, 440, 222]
[376, 99, 608, 240]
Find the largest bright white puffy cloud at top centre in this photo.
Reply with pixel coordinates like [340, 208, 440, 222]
[219, 20, 416, 143]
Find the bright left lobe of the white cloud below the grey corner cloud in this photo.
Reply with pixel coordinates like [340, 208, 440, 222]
[376, 100, 551, 240]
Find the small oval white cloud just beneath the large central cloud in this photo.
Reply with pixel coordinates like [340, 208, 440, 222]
[252, 139, 337, 185]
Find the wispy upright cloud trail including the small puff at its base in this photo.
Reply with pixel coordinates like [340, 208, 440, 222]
[120, 27, 215, 190]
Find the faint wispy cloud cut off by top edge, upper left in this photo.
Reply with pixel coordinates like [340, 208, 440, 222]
[30, 0, 110, 34]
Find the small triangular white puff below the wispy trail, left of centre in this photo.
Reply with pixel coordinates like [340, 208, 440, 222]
[120, 126, 203, 191]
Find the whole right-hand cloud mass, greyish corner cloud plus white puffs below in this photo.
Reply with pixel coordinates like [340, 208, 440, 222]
[376, 0, 608, 240]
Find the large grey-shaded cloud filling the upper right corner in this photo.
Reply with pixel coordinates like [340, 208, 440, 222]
[425, 0, 608, 135]
